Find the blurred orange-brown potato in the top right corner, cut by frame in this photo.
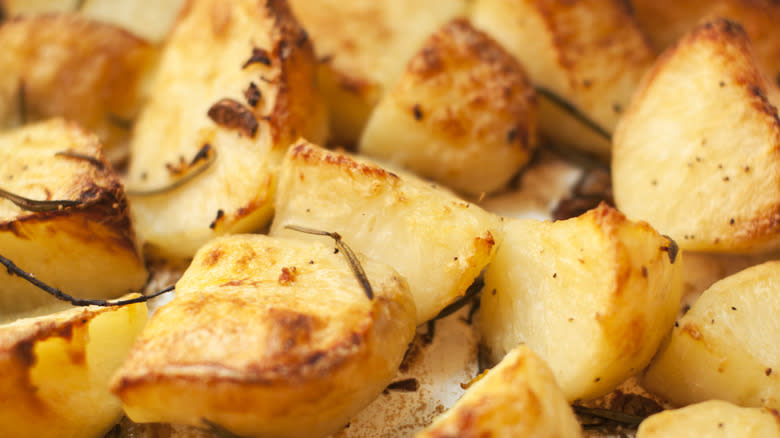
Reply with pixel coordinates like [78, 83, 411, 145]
[631, 0, 780, 85]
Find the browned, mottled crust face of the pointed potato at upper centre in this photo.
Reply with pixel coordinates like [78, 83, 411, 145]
[402, 18, 536, 150]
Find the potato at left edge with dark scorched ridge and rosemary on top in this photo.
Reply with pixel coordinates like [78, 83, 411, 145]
[0, 119, 147, 314]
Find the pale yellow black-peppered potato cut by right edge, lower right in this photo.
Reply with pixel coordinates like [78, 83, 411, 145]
[643, 261, 780, 409]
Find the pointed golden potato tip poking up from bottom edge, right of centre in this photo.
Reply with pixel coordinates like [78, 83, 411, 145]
[415, 345, 582, 438]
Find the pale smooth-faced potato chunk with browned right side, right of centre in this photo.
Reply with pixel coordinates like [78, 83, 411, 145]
[480, 204, 682, 401]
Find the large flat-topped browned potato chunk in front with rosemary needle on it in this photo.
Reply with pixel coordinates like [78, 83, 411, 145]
[112, 235, 415, 437]
